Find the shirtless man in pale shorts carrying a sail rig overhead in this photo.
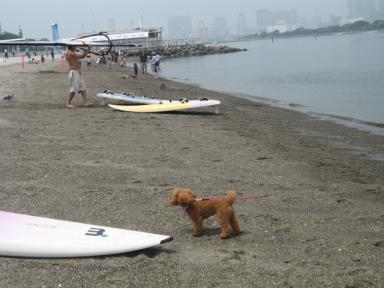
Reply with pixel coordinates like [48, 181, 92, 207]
[66, 45, 92, 108]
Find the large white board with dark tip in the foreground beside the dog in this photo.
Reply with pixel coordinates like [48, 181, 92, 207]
[0, 211, 173, 258]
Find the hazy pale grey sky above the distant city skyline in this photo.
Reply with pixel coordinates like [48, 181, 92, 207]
[0, 0, 347, 39]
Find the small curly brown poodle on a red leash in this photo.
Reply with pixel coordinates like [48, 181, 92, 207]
[169, 188, 240, 239]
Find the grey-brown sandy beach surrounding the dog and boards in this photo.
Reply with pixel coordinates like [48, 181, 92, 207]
[0, 59, 384, 288]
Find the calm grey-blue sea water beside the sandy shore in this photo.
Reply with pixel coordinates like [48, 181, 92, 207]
[161, 32, 384, 134]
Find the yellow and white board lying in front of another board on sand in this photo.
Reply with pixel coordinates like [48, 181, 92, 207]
[108, 100, 220, 113]
